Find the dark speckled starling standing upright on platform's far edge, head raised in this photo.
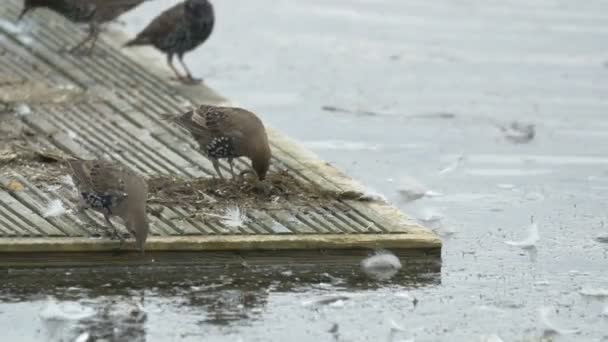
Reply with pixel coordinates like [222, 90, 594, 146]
[125, 0, 215, 83]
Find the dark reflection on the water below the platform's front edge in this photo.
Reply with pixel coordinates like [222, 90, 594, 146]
[0, 257, 440, 341]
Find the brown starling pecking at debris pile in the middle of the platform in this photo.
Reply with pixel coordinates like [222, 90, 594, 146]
[165, 105, 271, 181]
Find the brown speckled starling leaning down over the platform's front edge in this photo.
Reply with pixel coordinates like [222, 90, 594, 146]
[68, 160, 149, 253]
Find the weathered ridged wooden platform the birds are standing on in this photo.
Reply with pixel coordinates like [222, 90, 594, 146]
[0, 0, 441, 264]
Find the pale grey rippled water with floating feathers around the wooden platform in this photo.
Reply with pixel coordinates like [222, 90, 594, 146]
[0, 0, 608, 342]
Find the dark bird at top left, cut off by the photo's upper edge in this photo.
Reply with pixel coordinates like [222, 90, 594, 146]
[18, 0, 147, 54]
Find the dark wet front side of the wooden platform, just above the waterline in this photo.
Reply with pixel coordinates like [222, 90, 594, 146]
[0, 249, 440, 270]
